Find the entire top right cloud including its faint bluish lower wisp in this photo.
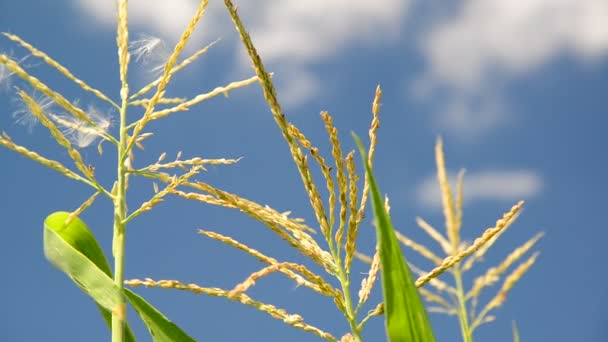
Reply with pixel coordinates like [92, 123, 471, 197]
[413, 0, 608, 135]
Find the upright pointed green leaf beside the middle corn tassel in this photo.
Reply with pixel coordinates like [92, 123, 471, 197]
[353, 133, 435, 342]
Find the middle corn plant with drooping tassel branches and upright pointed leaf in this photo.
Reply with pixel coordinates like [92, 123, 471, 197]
[126, 0, 536, 341]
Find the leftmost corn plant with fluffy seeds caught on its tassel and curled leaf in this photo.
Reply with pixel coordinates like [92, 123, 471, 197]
[0, 0, 257, 342]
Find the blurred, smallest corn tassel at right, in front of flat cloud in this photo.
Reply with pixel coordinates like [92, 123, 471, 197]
[357, 139, 543, 342]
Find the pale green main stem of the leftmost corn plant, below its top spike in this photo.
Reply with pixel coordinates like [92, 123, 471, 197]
[112, 91, 129, 342]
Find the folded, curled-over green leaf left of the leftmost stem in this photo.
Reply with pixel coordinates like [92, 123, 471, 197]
[44, 212, 136, 342]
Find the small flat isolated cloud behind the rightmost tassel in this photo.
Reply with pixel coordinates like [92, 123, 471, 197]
[416, 170, 543, 208]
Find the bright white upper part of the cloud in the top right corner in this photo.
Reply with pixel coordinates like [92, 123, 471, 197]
[424, 0, 608, 88]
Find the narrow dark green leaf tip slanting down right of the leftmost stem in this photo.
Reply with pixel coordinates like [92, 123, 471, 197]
[125, 289, 195, 342]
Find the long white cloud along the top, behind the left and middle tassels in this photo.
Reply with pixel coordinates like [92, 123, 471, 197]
[76, 0, 410, 105]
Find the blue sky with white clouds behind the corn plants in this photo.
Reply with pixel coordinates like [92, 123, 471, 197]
[0, 0, 608, 342]
